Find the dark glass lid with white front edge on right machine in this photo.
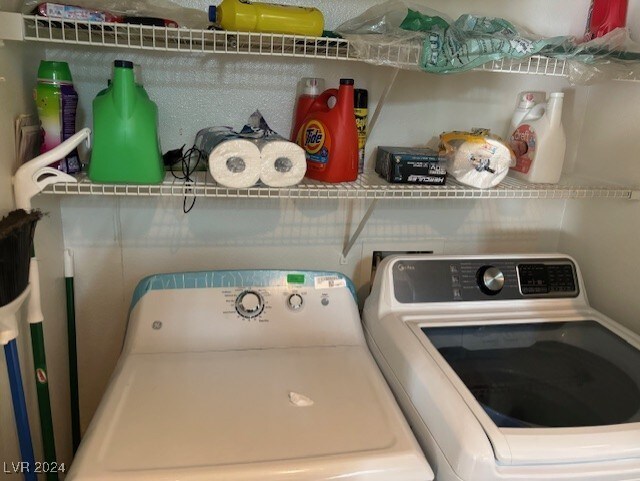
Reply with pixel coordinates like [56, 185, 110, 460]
[421, 312, 640, 465]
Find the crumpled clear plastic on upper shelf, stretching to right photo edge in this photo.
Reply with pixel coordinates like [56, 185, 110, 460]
[336, 0, 640, 85]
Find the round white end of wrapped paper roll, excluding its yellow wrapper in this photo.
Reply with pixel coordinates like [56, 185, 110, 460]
[447, 138, 513, 189]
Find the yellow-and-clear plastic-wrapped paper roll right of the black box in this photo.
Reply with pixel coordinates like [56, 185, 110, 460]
[440, 129, 516, 189]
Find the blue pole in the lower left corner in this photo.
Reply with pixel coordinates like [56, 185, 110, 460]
[4, 339, 38, 481]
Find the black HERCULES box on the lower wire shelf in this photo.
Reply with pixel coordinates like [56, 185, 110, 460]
[376, 147, 447, 185]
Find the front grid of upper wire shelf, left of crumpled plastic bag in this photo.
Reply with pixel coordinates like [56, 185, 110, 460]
[23, 15, 353, 60]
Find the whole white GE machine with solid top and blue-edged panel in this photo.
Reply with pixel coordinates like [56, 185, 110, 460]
[67, 271, 433, 481]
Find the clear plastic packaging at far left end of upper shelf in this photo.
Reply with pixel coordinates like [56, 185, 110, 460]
[22, 0, 209, 29]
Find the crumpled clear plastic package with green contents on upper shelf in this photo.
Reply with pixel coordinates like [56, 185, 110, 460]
[336, 0, 571, 73]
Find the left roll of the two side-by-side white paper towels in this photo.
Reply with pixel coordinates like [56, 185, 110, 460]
[209, 139, 262, 189]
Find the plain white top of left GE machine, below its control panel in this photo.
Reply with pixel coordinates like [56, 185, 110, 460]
[70, 347, 433, 481]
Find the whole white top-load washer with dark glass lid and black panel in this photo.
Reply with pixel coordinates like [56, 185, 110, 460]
[363, 254, 640, 481]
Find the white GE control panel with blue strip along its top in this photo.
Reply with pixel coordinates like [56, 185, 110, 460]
[127, 270, 363, 352]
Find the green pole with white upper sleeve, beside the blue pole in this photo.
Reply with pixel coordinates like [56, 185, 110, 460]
[27, 255, 58, 481]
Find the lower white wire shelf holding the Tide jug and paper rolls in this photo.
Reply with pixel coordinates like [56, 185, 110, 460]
[44, 172, 640, 199]
